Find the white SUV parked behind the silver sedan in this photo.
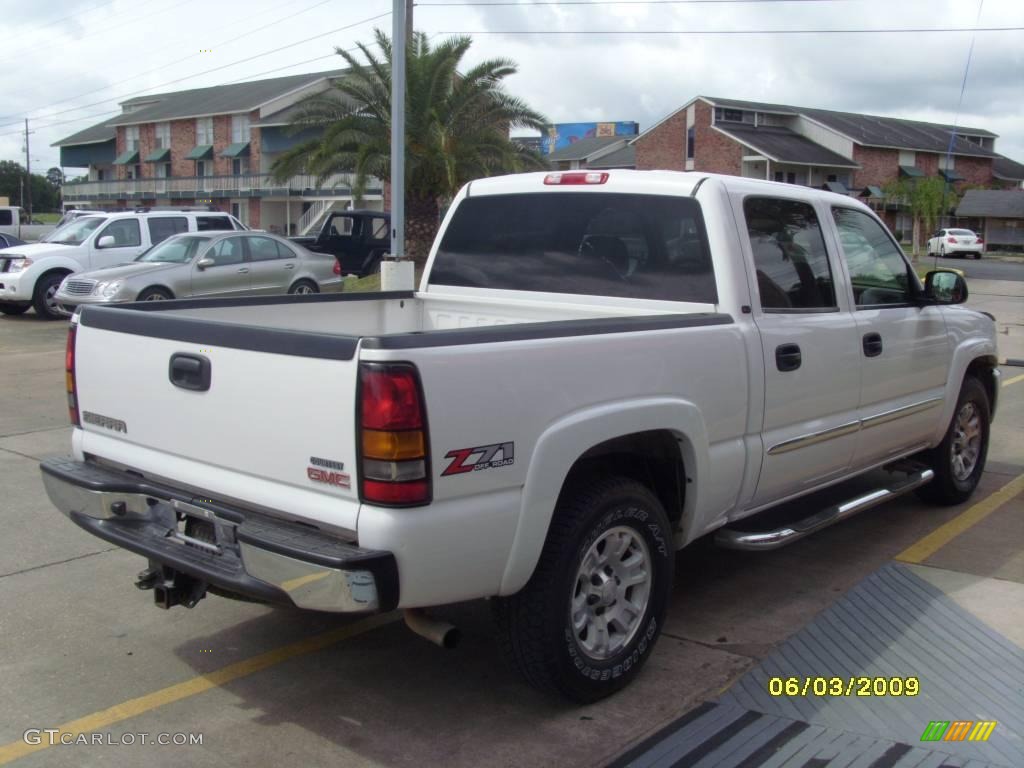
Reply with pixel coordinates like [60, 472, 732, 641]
[0, 211, 246, 319]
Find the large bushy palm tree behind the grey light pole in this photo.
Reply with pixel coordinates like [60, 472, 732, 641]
[271, 30, 548, 262]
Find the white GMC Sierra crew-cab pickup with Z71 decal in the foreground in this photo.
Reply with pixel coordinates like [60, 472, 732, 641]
[42, 171, 998, 701]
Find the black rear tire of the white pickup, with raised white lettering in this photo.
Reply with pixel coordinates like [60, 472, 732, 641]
[492, 476, 675, 703]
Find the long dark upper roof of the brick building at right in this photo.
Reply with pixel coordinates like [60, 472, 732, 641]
[700, 96, 996, 158]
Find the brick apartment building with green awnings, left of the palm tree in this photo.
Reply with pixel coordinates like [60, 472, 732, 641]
[54, 71, 384, 233]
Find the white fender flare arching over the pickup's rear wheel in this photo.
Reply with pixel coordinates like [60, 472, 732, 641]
[499, 397, 710, 595]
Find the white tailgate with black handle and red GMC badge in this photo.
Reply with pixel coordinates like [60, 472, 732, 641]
[75, 308, 358, 531]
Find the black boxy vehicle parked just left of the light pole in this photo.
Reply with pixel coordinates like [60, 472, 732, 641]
[289, 211, 391, 278]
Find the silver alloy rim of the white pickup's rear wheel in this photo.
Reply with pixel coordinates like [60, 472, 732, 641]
[569, 525, 651, 660]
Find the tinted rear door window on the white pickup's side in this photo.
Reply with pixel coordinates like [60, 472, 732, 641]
[743, 198, 839, 312]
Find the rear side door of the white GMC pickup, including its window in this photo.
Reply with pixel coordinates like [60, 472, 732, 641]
[741, 197, 860, 506]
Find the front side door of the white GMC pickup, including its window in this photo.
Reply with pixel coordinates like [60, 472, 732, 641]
[831, 206, 952, 467]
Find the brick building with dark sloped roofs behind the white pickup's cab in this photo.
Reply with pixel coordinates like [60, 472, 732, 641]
[632, 96, 1024, 232]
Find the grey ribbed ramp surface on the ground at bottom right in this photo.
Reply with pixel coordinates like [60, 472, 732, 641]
[612, 563, 1024, 768]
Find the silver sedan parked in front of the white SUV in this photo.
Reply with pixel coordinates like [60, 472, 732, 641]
[56, 231, 343, 314]
